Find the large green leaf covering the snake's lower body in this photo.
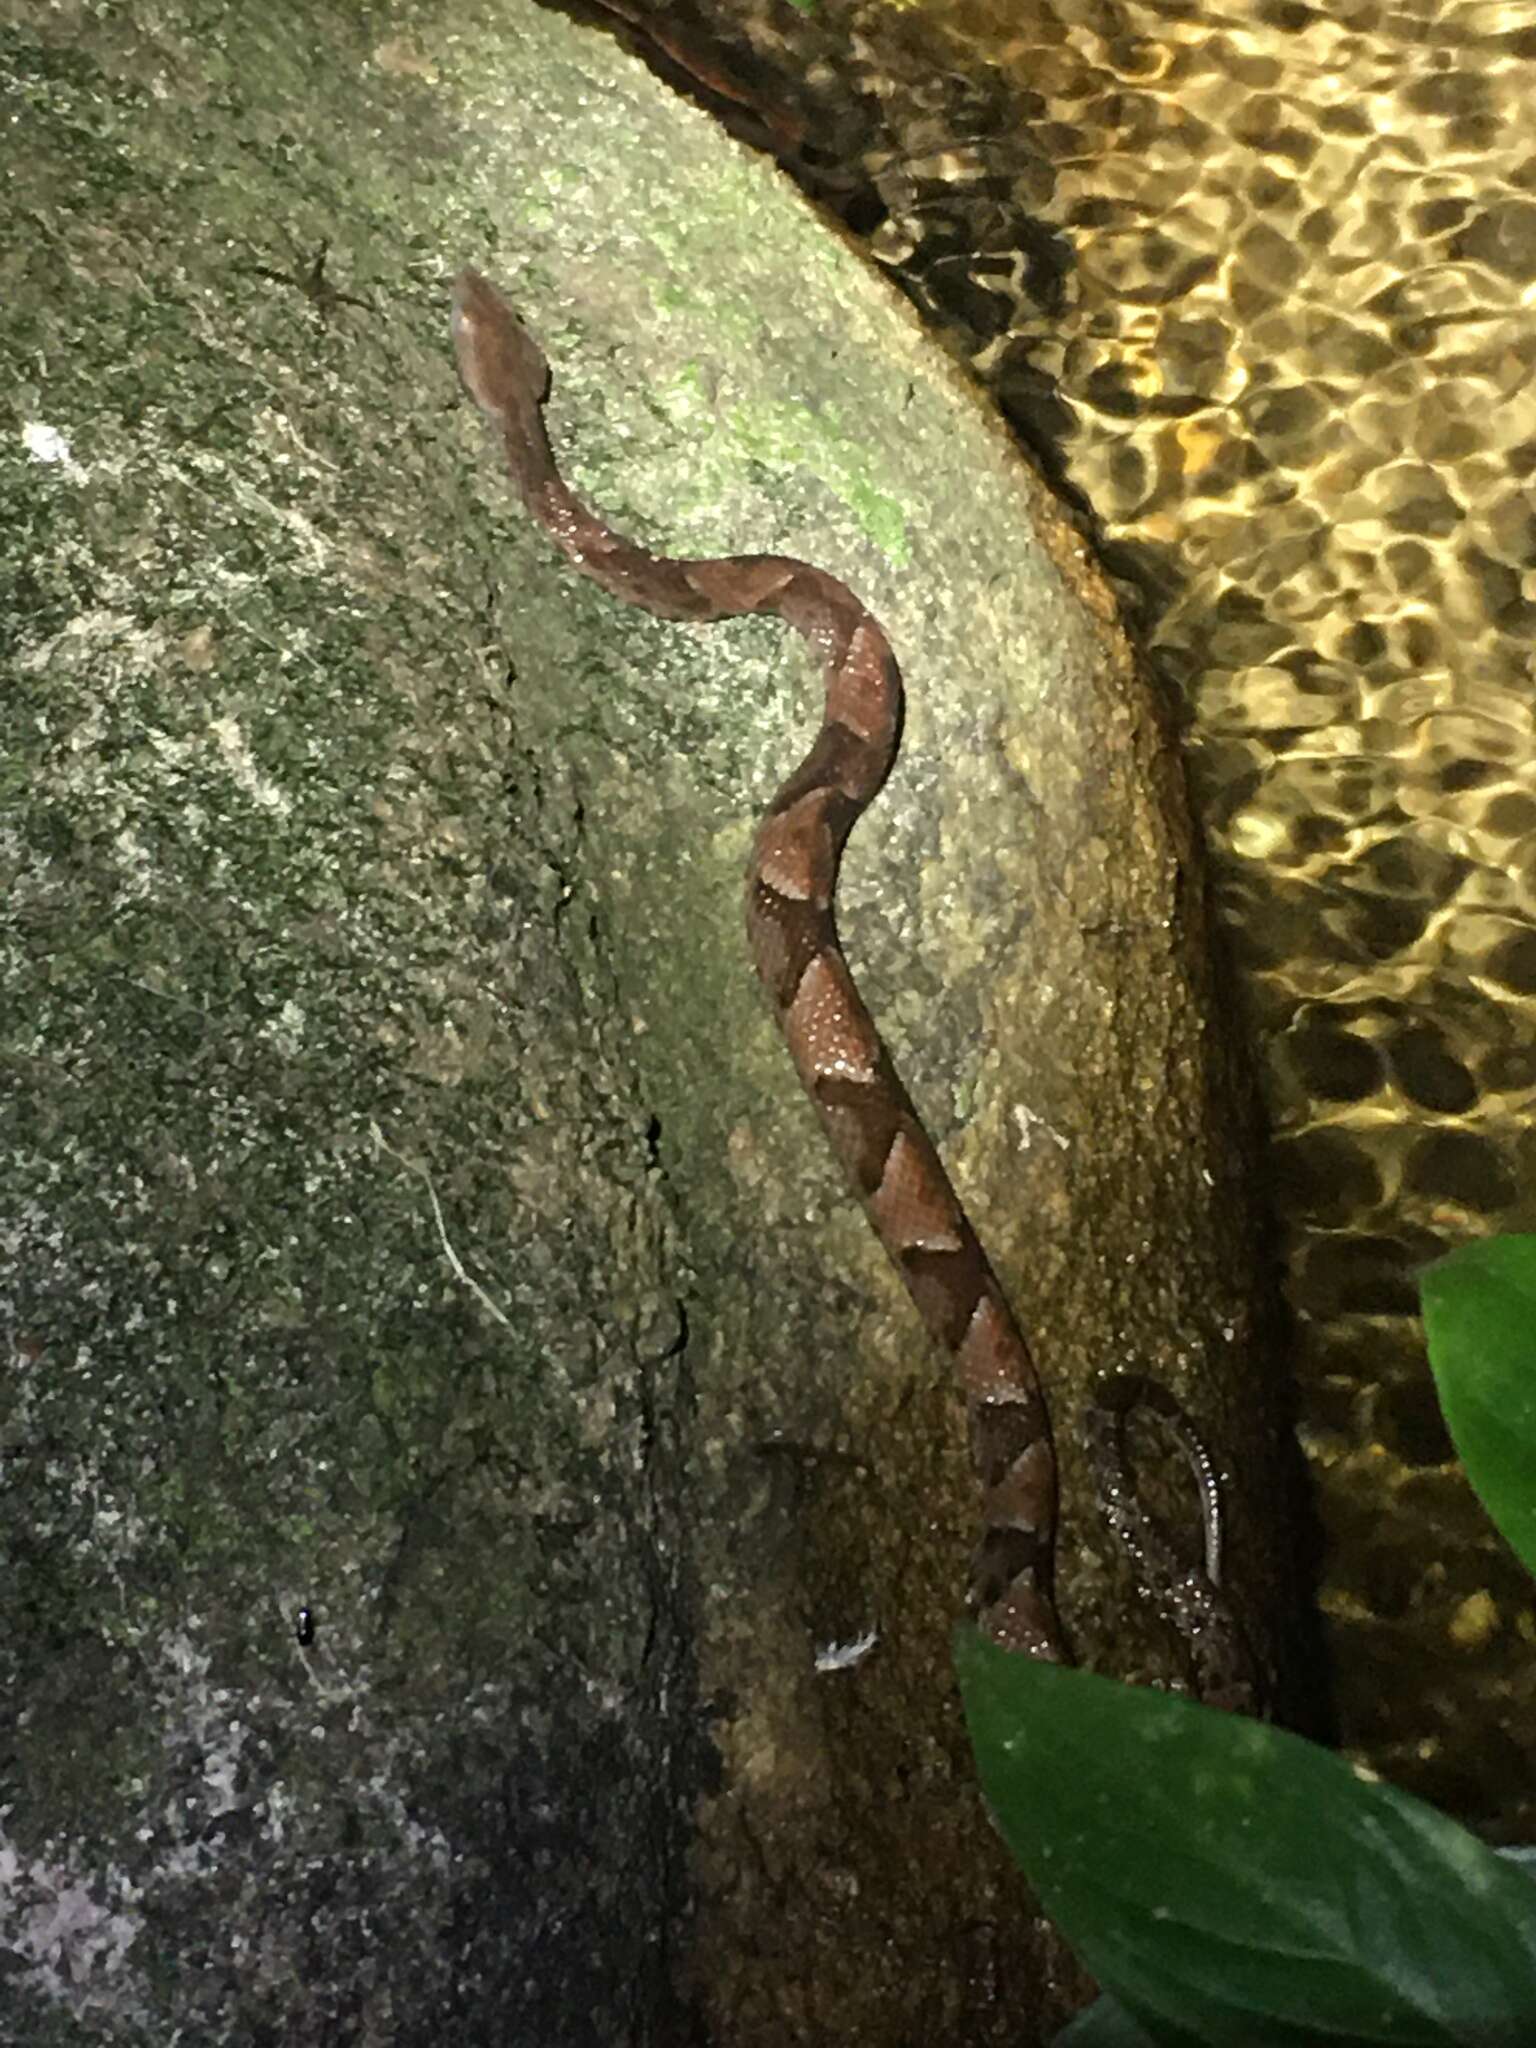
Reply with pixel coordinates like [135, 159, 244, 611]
[954, 1626, 1536, 2048]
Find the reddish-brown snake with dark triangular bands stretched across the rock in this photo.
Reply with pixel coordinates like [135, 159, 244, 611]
[453, 270, 1249, 1706]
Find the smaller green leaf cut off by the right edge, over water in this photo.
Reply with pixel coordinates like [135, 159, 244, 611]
[1419, 1237, 1536, 1572]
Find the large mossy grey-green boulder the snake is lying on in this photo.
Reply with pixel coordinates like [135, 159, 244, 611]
[0, 0, 1294, 2048]
